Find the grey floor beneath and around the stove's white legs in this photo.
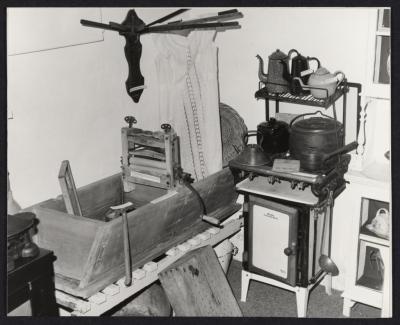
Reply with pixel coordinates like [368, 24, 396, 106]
[227, 260, 380, 318]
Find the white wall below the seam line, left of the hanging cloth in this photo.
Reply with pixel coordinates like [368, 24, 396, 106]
[7, 8, 166, 207]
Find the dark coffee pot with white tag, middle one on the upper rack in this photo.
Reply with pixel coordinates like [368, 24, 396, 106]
[282, 49, 321, 96]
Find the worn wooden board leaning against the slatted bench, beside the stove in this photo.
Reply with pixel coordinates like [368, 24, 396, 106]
[159, 246, 243, 317]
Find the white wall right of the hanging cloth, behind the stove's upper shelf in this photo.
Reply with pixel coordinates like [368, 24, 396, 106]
[212, 8, 369, 141]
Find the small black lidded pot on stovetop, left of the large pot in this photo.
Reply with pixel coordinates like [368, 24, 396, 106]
[257, 117, 289, 155]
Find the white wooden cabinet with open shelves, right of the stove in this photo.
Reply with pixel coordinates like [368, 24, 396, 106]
[342, 173, 391, 317]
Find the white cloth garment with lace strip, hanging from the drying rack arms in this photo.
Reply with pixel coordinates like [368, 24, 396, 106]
[153, 31, 222, 181]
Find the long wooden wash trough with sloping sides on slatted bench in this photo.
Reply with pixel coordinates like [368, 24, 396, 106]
[26, 168, 238, 298]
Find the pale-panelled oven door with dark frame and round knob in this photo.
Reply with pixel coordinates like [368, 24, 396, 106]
[245, 195, 299, 286]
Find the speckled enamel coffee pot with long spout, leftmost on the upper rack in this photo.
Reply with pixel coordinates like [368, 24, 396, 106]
[256, 49, 289, 93]
